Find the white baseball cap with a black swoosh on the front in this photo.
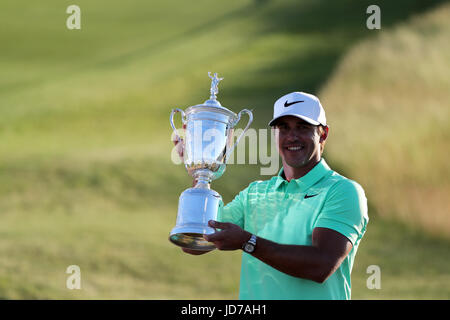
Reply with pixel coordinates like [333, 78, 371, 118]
[269, 92, 327, 126]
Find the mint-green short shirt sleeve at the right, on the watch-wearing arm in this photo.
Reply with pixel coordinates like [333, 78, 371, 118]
[315, 180, 369, 245]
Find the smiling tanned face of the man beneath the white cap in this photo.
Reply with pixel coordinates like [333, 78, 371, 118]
[274, 116, 328, 168]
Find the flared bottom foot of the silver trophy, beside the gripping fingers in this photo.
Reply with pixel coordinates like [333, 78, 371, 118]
[169, 226, 216, 251]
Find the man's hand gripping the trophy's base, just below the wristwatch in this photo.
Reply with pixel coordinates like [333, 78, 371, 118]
[203, 220, 251, 250]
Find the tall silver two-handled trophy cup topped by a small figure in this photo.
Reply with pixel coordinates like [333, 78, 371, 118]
[169, 72, 253, 250]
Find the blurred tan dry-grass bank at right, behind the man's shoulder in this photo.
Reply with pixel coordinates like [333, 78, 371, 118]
[321, 1, 450, 239]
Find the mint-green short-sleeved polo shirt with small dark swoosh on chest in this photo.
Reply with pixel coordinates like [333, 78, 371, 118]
[219, 159, 369, 300]
